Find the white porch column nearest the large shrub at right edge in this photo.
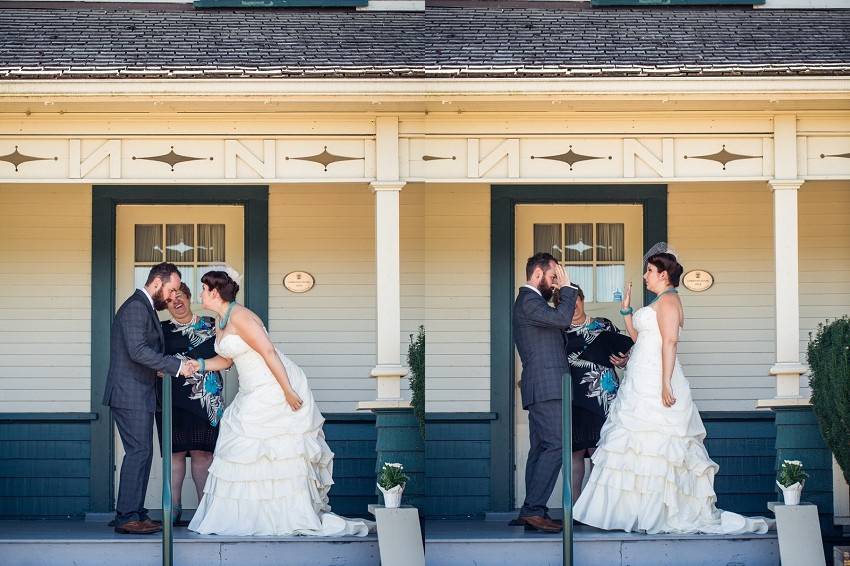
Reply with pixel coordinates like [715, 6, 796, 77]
[758, 115, 809, 407]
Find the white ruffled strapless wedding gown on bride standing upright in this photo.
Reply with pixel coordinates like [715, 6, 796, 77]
[573, 307, 772, 534]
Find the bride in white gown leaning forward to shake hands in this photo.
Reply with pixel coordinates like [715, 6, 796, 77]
[189, 271, 370, 536]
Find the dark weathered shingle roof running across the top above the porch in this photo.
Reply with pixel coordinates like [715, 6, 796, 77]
[0, 3, 850, 79]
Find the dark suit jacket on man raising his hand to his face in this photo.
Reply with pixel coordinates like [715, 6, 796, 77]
[513, 287, 578, 409]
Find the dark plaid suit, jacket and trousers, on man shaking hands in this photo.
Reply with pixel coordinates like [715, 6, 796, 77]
[103, 290, 180, 525]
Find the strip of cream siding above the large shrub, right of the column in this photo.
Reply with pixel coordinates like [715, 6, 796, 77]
[799, 181, 850, 395]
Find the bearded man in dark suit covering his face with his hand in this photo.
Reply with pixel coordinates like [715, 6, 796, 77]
[513, 253, 578, 533]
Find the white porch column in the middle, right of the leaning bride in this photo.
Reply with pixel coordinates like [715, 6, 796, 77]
[358, 117, 410, 409]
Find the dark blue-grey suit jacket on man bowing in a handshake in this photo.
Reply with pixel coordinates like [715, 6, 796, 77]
[103, 290, 180, 413]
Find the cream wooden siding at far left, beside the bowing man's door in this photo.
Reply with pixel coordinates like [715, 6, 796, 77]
[0, 185, 92, 413]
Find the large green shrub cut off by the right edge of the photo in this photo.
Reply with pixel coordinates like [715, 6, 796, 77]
[808, 316, 850, 482]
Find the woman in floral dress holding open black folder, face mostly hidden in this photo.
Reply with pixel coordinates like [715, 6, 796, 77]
[565, 288, 628, 503]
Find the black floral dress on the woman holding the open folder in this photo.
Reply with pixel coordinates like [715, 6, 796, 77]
[566, 318, 619, 451]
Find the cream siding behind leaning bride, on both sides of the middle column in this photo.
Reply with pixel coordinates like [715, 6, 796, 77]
[269, 184, 412, 412]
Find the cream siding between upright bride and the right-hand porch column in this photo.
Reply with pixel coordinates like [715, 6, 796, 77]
[668, 183, 776, 411]
